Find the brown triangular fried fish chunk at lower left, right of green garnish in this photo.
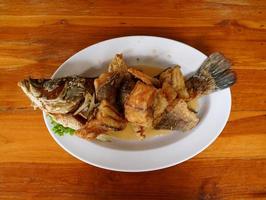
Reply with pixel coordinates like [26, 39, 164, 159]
[75, 100, 126, 139]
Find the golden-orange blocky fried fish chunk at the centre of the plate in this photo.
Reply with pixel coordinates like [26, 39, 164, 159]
[125, 81, 157, 127]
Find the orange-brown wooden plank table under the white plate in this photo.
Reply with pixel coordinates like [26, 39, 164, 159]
[0, 0, 266, 200]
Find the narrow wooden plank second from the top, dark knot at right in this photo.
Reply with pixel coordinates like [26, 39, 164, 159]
[0, 15, 266, 30]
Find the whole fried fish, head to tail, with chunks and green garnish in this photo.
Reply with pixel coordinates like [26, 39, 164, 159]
[18, 53, 236, 140]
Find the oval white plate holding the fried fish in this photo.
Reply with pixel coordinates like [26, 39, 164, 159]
[44, 36, 231, 172]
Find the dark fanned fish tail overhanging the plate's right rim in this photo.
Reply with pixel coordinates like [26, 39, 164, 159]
[186, 52, 236, 98]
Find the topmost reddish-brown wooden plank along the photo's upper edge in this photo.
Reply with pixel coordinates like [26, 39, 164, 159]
[0, 0, 265, 18]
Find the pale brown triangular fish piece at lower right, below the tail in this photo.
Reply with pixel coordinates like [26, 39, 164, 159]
[153, 99, 199, 131]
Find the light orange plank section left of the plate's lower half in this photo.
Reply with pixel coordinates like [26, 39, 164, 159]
[0, 109, 80, 163]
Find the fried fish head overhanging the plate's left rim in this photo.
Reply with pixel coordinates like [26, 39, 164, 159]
[18, 77, 91, 114]
